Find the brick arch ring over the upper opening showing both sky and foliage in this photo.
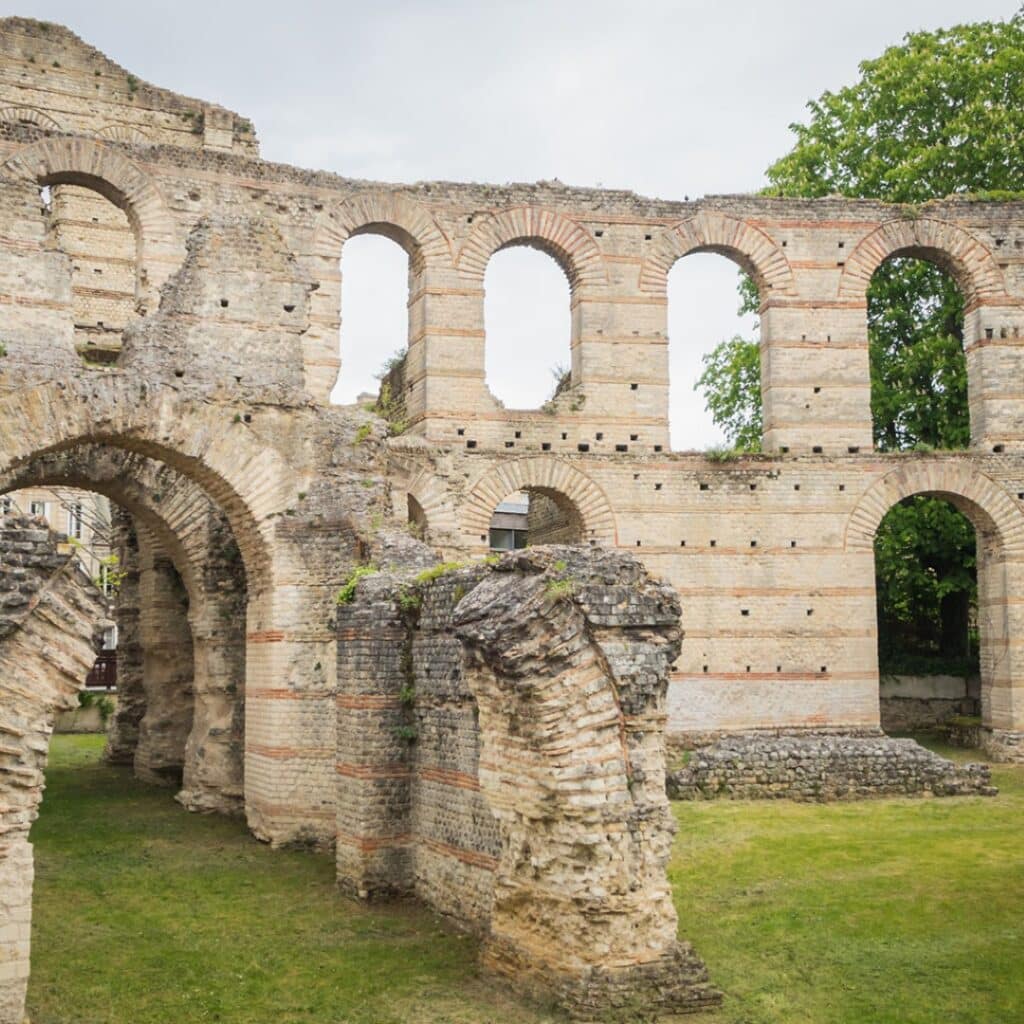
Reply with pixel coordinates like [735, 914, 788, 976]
[640, 210, 794, 302]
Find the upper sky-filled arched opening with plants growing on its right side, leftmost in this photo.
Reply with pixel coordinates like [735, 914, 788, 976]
[331, 234, 413, 406]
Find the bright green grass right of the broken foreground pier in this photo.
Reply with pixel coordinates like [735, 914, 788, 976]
[670, 742, 1024, 1024]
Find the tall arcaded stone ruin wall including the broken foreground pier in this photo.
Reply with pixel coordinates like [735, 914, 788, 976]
[6, 18, 1024, 1024]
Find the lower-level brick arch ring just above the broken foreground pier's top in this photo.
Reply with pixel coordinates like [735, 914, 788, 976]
[462, 457, 618, 549]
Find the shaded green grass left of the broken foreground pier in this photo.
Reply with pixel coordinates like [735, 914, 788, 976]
[29, 735, 557, 1024]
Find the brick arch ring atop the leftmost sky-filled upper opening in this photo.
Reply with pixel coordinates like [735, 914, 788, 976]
[312, 191, 452, 271]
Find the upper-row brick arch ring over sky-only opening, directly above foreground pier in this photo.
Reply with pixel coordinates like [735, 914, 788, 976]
[458, 206, 608, 291]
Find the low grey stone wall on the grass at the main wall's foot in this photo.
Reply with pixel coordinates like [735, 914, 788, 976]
[668, 735, 997, 802]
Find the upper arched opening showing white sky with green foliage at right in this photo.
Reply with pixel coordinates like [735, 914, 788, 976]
[668, 251, 762, 452]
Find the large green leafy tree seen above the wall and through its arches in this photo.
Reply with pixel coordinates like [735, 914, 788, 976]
[698, 16, 1024, 675]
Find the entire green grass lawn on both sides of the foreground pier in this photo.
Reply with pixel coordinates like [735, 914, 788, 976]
[29, 736, 1024, 1024]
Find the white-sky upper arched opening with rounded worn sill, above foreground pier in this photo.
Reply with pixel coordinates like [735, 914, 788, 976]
[484, 243, 573, 410]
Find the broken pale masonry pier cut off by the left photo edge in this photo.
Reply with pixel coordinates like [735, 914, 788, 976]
[0, 516, 108, 1024]
